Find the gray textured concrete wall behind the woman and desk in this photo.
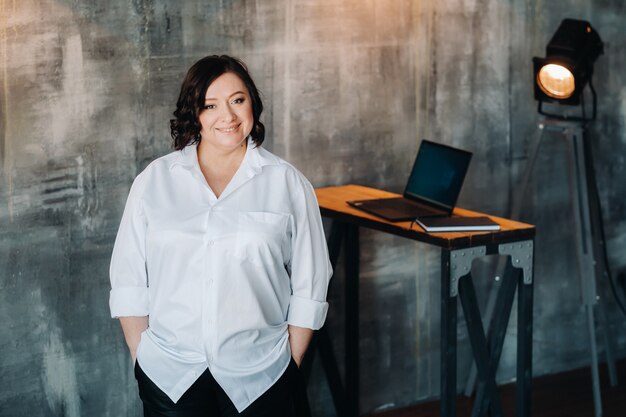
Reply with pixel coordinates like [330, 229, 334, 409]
[0, 0, 626, 416]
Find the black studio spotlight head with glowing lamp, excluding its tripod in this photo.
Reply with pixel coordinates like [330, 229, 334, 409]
[533, 19, 604, 120]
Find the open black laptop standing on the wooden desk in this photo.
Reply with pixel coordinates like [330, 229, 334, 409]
[347, 139, 472, 222]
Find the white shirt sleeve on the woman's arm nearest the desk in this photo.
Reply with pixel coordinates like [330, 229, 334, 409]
[287, 175, 332, 330]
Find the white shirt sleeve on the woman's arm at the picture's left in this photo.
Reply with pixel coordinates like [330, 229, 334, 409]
[109, 175, 149, 318]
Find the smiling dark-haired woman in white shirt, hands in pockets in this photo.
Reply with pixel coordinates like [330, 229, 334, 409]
[110, 56, 332, 417]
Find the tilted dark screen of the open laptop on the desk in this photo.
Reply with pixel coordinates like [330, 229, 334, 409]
[404, 140, 472, 210]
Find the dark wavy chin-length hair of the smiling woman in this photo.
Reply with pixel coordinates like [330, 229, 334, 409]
[170, 55, 265, 150]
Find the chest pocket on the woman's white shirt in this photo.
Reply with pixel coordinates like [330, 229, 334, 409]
[232, 212, 289, 266]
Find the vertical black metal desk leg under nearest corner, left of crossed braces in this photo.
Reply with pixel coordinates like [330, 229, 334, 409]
[440, 249, 457, 417]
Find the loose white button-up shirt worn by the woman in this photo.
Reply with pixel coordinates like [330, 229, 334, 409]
[109, 141, 332, 411]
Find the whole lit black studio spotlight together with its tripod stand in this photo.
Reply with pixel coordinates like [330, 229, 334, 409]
[515, 19, 626, 417]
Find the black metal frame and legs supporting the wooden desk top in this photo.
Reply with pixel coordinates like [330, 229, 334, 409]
[302, 216, 534, 417]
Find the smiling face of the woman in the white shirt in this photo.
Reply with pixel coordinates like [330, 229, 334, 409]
[199, 72, 254, 152]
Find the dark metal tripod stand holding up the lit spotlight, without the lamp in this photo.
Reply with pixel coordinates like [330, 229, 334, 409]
[465, 118, 617, 417]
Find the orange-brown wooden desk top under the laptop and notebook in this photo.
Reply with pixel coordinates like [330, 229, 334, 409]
[315, 184, 535, 250]
